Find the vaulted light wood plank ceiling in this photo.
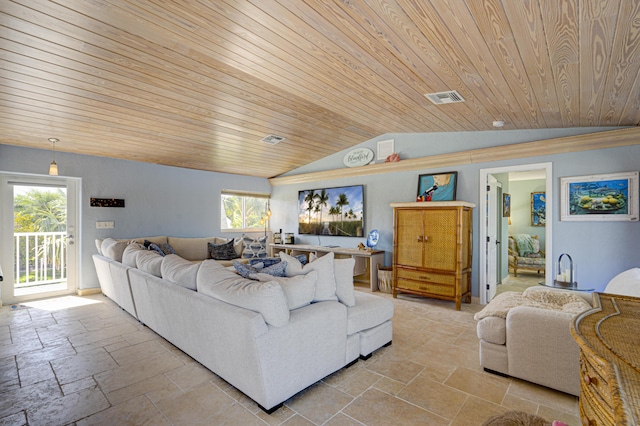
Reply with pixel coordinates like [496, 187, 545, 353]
[0, 0, 640, 177]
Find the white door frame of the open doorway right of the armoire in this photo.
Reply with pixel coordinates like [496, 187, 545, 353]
[478, 163, 554, 305]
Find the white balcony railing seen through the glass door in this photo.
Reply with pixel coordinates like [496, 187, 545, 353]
[14, 232, 67, 288]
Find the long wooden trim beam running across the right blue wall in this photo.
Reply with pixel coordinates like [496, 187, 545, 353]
[269, 127, 640, 186]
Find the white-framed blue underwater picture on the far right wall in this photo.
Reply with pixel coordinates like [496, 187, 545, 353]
[560, 172, 638, 221]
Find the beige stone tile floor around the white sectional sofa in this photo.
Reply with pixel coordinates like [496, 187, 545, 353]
[0, 289, 580, 426]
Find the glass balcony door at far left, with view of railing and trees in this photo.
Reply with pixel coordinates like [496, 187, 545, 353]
[0, 173, 80, 303]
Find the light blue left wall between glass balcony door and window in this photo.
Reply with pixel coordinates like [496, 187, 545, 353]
[0, 145, 271, 288]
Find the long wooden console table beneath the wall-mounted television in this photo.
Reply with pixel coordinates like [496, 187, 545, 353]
[269, 244, 384, 291]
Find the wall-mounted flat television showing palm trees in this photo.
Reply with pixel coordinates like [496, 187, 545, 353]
[298, 185, 365, 237]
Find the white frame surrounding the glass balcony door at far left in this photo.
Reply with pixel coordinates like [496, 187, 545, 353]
[0, 171, 82, 306]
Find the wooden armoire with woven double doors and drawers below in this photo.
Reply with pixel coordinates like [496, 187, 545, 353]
[391, 201, 475, 310]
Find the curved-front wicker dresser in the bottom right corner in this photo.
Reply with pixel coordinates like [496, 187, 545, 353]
[571, 293, 640, 426]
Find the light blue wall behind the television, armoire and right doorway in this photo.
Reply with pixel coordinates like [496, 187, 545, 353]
[271, 129, 640, 296]
